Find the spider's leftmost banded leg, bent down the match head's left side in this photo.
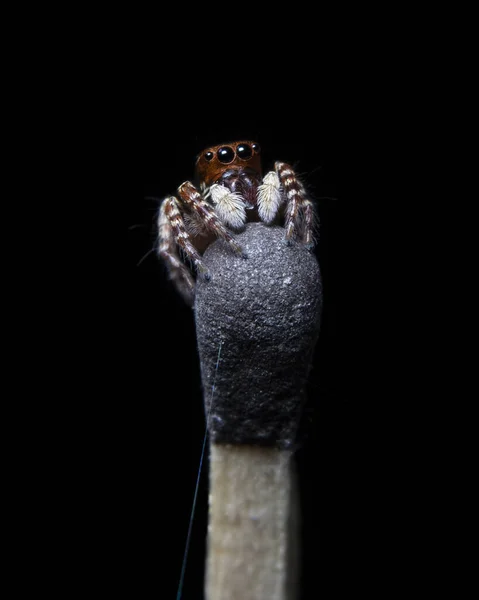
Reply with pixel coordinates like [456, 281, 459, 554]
[158, 196, 205, 305]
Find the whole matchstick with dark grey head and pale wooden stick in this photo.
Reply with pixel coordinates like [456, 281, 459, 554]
[195, 223, 322, 600]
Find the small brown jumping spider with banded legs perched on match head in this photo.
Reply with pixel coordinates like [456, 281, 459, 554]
[158, 141, 315, 306]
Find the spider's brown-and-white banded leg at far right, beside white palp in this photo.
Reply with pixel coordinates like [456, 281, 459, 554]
[274, 162, 315, 248]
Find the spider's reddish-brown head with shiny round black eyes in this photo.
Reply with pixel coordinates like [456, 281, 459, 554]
[196, 141, 261, 187]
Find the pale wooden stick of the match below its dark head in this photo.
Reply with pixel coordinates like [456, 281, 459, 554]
[205, 443, 298, 600]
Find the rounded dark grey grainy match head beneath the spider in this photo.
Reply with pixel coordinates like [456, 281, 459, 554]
[194, 223, 322, 448]
